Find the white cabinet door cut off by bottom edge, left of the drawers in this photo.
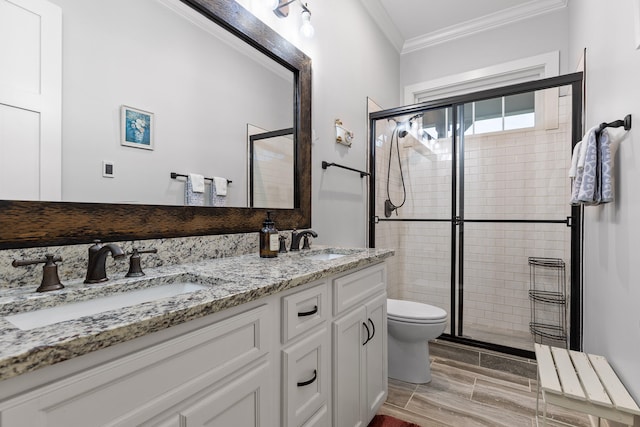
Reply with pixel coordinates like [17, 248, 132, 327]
[178, 361, 274, 427]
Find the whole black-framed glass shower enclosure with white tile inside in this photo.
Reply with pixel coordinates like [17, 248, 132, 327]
[369, 73, 582, 357]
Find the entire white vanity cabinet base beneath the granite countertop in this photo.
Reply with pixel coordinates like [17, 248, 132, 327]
[0, 263, 387, 427]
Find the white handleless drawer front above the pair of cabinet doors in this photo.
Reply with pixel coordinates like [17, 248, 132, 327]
[333, 263, 387, 316]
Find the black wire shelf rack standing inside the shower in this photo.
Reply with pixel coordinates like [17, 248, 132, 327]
[529, 257, 567, 347]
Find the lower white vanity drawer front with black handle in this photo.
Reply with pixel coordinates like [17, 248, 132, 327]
[281, 327, 330, 427]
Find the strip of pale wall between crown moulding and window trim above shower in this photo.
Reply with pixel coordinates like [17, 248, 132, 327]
[400, 8, 571, 88]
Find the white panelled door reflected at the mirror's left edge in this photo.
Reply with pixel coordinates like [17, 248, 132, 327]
[0, 0, 62, 201]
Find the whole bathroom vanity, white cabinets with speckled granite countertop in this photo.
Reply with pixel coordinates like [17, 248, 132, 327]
[0, 248, 393, 426]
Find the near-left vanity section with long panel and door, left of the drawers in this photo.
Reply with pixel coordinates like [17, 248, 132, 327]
[0, 304, 278, 427]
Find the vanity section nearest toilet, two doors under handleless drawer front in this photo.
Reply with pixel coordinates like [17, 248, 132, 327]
[332, 264, 387, 427]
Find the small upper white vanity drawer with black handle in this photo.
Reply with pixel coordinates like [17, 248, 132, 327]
[282, 281, 329, 344]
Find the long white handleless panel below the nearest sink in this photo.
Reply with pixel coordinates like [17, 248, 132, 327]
[0, 305, 274, 427]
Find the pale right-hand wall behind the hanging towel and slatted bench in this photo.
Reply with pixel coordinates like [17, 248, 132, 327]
[569, 0, 640, 400]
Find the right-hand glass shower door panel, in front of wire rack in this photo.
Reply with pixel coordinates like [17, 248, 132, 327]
[457, 89, 571, 351]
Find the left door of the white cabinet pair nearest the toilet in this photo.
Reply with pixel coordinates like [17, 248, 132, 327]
[333, 306, 368, 427]
